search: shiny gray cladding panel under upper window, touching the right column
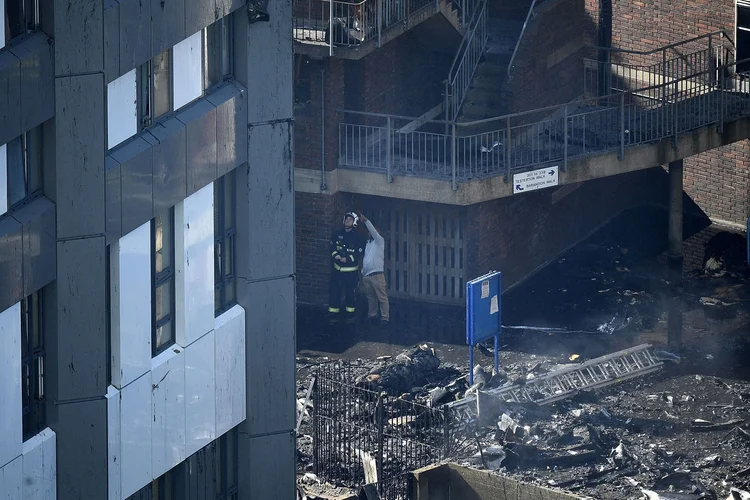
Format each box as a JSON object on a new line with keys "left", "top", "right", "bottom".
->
{"left": 208, "top": 84, "right": 247, "bottom": 177}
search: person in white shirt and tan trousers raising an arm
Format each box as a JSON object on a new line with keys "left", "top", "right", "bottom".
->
{"left": 358, "top": 214, "right": 391, "bottom": 326}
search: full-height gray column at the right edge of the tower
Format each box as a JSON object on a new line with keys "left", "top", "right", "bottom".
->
{"left": 234, "top": 2, "right": 296, "bottom": 500}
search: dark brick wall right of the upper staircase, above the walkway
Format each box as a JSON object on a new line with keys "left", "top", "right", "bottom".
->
{"left": 509, "top": 0, "right": 589, "bottom": 112}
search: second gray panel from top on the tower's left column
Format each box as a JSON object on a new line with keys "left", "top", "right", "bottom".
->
{"left": 55, "top": 73, "right": 106, "bottom": 238}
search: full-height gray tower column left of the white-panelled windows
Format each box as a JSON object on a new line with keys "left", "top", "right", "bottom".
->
{"left": 45, "top": 0, "right": 109, "bottom": 500}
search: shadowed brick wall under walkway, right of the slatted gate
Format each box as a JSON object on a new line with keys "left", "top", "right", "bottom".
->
{"left": 467, "top": 168, "right": 667, "bottom": 287}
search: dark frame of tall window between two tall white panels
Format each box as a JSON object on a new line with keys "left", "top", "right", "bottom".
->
{"left": 151, "top": 207, "right": 176, "bottom": 357}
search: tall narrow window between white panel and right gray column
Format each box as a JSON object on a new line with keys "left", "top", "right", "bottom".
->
{"left": 214, "top": 171, "right": 237, "bottom": 316}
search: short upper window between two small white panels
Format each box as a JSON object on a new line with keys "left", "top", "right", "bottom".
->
{"left": 137, "top": 50, "right": 172, "bottom": 129}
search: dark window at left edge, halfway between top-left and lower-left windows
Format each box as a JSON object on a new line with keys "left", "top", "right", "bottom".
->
{"left": 6, "top": 127, "right": 42, "bottom": 208}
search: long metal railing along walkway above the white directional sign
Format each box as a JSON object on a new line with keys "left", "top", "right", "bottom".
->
{"left": 339, "top": 55, "right": 750, "bottom": 189}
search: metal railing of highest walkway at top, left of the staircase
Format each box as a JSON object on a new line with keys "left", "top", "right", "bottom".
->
{"left": 292, "top": 0, "right": 440, "bottom": 55}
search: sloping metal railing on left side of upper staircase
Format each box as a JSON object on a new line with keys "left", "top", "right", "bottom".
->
{"left": 443, "top": 0, "right": 487, "bottom": 120}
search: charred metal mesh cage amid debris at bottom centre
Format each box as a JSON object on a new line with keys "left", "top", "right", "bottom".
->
{"left": 312, "top": 361, "right": 457, "bottom": 500}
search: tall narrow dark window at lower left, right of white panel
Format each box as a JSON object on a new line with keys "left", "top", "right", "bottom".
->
{"left": 21, "top": 290, "right": 47, "bottom": 441}
